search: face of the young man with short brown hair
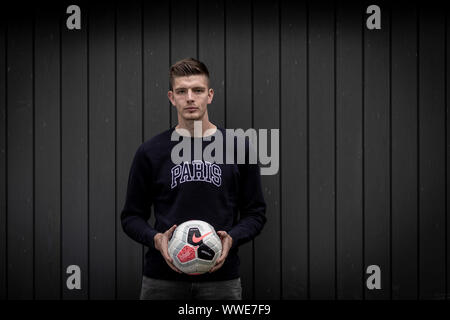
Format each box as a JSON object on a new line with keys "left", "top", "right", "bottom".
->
{"left": 167, "top": 75, "right": 214, "bottom": 120}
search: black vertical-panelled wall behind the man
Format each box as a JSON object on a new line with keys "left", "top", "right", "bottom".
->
{"left": 0, "top": 0, "right": 450, "bottom": 300}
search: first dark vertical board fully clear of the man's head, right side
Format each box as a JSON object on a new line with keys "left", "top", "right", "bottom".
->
{"left": 225, "top": 0, "right": 254, "bottom": 299}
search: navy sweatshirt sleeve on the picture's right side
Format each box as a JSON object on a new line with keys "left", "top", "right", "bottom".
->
{"left": 228, "top": 137, "right": 266, "bottom": 249}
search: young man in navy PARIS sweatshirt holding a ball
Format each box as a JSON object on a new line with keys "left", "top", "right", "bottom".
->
{"left": 121, "top": 58, "right": 266, "bottom": 300}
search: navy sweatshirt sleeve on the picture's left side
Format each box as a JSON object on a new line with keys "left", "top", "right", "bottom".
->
{"left": 121, "top": 145, "right": 157, "bottom": 248}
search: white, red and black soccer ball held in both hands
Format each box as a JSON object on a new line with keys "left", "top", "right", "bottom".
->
{"left": 168, "top": 220, "right": 222, "bottom": 275}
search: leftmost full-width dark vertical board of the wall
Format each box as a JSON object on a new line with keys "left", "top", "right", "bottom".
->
{"left": 6, "top": 10, "right": 34, "bottom": 299}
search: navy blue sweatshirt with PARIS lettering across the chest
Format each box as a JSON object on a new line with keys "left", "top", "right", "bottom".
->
{"left": 121, "top": 127, "right": 266, "bottom": 281}
